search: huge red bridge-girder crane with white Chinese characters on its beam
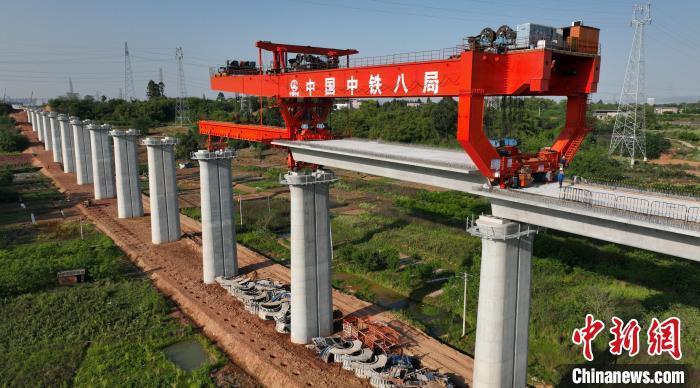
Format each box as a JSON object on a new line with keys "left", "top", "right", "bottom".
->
{"left": 199, "top": 22, "right": 600, "bottom": 186}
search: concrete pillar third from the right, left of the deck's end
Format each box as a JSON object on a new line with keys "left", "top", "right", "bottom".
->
{"left": 192, "top": 150, "right": 238, "bottom": 284}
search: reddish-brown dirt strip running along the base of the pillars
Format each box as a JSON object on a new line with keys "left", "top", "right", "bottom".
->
{"left": 16, "top": 113, "right": 473, "bottom": 387}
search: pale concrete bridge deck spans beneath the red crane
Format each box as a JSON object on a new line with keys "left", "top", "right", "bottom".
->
{"left": 272, "top": 139, "right": 700, "bottom": 261}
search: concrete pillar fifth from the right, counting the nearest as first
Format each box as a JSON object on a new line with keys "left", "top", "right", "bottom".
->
{"left": 109, "top": 129, "right": 143, "bottom": 218}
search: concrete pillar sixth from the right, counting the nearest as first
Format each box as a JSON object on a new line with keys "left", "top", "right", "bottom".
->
{"left": 88, "top": 124, "right": 116, "bottom": 199}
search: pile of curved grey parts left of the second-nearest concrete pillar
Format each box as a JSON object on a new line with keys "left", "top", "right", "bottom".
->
{"left": 215, "top": 276, "right": 291, "bottom": 333}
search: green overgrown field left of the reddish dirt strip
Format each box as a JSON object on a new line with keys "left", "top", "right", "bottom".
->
{"left": 0, "top": 169, "right": 235, "bottom": 387}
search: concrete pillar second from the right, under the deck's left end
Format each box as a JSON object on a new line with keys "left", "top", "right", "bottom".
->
{"left": 283, "top": 170, "right": 335, "bottom": 344}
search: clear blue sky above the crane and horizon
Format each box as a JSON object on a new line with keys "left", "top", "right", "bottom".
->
{"left": 0, "top": 0, "right": 700, "bottom": 101}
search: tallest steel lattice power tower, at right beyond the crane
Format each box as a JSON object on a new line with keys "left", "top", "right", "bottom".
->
{"left": 608, "top": 3, "right": 651, "bottom": 166}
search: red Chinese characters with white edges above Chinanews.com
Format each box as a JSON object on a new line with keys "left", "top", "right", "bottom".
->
{"left": 571, "top": 314, "right": 683, "bottom": 361}
